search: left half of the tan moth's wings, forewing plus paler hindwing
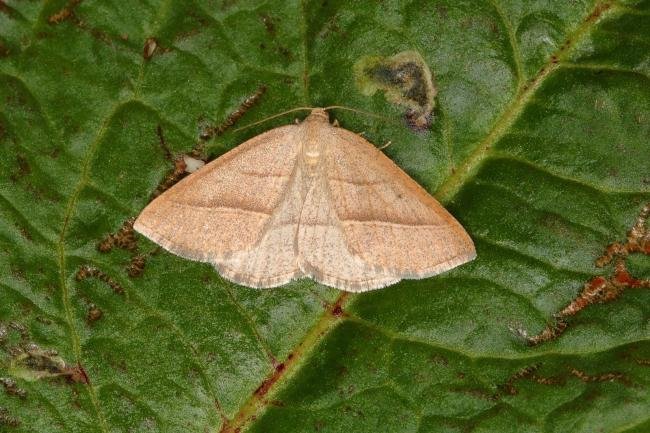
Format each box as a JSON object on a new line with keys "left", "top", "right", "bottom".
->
{"left": 134, "top": 125, "right": 302, "bottom": 287}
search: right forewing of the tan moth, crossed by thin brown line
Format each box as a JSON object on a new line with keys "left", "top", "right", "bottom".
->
{"left": 324, "top": 128, "right": 476, "bottom": 279}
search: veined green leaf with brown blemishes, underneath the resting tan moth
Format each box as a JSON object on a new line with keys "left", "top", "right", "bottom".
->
{"left": 0, "top": 0, "right": 650, "bottom": 433}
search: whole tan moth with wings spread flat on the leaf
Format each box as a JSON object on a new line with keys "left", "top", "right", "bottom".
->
{"left": 133, "top": 108, "right": 476, "bottom": 292}
